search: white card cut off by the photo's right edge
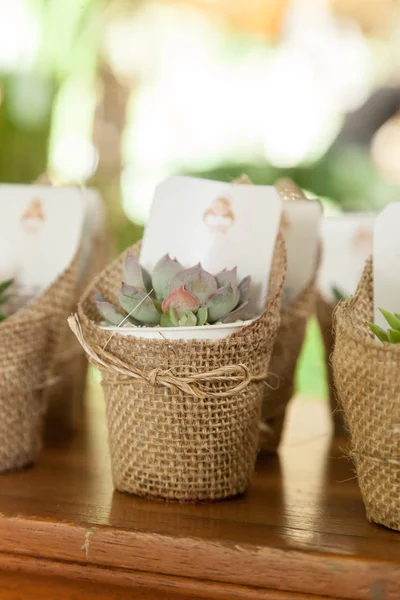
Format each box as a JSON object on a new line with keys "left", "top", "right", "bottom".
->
{"left": 374, "top": 202, "right": 400, "bottom": 329}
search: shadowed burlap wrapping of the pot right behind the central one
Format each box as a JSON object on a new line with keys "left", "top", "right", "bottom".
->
{"left": 260, "top": 279, "right": 316, "bottom": 454}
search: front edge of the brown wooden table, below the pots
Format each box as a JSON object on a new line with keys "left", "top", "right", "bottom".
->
{"left": 0, "top": 516, "right": 400, "bottom": 600}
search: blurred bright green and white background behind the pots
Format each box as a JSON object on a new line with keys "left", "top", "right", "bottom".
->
{"left": 0, "top": 0, "right": 400, "bottom": 397}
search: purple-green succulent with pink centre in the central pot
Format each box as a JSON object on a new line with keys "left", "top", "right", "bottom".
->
{"left": 95, "top": 252, "right": 251, "bottom": 327}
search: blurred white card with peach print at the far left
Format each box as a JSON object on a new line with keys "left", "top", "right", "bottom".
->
{"left": 0, "top": 184, "right": 85, "bottom": 295}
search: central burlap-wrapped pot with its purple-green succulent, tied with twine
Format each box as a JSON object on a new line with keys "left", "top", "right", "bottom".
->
{"left": 69, "top": 239, "right": 285, "bottom": 502}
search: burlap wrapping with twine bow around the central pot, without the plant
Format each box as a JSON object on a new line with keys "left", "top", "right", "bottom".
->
{"left": 70, "top": 239, "right": 286, "bottom": 502}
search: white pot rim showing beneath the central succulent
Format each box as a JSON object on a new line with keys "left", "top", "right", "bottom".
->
{"left": 99, "top": 319, "right": 254, "bottom": 341}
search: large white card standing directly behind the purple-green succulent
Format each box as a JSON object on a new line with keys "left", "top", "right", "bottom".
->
{"left": 140, "top": 176, "right": 282, "bottom": 313}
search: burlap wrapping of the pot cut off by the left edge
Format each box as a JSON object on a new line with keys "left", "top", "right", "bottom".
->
{"left": 0, "top": 260, "right": 76, "bottom": 472}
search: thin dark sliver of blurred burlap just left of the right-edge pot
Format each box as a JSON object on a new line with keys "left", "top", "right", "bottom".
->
{"left": 316, "top": 294, "right": 347, "bottom": 436}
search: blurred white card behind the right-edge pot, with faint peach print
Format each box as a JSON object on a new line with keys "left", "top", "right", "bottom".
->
{"left": 318, "top": 212, "right": 376, "bottom": 303}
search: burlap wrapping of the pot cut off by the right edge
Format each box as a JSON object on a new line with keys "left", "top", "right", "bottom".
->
{"left": 332, "top": 260, "right": 400, "bottom": 530}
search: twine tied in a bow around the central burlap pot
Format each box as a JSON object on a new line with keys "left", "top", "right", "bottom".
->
{"left": 68, "top": 315, "right": 274, "bottom": 399}
